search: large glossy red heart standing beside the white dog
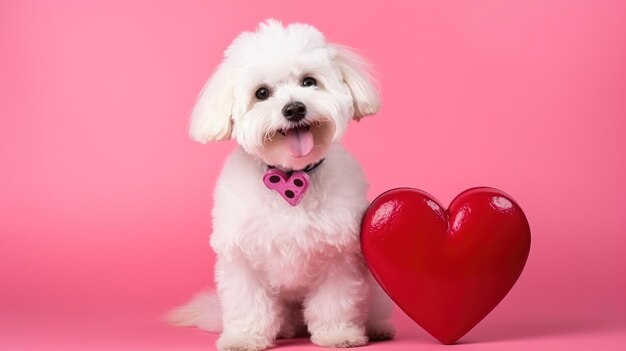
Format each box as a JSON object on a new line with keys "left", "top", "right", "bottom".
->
{"left": 361, "top": 188, "right": 530, "bottom": 344}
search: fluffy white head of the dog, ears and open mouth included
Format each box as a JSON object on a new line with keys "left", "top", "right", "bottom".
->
{"left": 190, "top": 20, "right": 380, "bottom": 169}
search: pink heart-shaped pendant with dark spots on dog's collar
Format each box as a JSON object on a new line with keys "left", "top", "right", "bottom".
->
{"left": 263, "top": 168, "right": 309, "bottom": 206}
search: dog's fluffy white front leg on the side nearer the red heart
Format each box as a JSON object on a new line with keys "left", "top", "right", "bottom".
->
{"left": 304, "top": 253, "right": 369, "bottom": 347}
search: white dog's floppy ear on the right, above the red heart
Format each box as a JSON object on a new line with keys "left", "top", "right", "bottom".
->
{"left": 332, "top": 45, "right": 380, "bottom": 120}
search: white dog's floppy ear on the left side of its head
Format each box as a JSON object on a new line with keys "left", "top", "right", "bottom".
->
{"left": 189, "top": 63, "right": 234, "bottom": 144}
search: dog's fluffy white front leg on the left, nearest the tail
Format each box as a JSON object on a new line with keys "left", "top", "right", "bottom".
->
{"left": 216, "top": 257, "right": 280, "bottom": 351}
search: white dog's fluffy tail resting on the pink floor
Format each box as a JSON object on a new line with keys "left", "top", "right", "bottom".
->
{"left": 165, "top": 291, "right": 222, "bottom": 333}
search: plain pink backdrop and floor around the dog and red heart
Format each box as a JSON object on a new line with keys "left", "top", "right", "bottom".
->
{"left": 0, "top": 0, "right": 626, "bottom": 350}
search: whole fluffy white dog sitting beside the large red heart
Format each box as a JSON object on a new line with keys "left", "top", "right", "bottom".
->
{"left": 170, "top": 20, "right": 394, "bottom": 350}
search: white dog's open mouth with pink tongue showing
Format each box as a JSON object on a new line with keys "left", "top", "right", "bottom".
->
{"left": 266, "top": 120, "right": 329, "bottom": 158}
